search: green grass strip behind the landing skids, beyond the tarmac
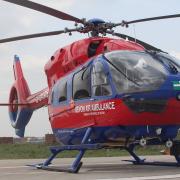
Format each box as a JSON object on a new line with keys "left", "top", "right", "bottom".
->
{"left": 0, "top": 144, "right": 164, "bottom": 159}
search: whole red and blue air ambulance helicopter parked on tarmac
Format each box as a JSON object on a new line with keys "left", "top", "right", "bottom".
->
{"left": 0, "top": 0, "right": 180, "bottom": 173}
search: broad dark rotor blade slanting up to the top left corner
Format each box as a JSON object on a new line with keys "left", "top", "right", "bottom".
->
{"left": 3, "top": 0, "right": 84, "bottom": 24}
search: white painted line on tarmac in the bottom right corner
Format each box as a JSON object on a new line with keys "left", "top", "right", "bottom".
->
{"left": 96, "top": 174, "right": 180, "bottom": 180}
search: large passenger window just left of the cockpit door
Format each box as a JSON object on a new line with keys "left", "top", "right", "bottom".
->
{"left": 73, "top": 67, "right": 91, "bottom": 99}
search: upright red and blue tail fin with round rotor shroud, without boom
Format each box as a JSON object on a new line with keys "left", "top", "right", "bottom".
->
{"left": 9, "top": 55, "right": 33, "bottom": 137}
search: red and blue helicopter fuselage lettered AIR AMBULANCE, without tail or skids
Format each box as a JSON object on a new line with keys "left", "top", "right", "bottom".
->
{"left": 45, "top": 38, "right": 180, "bottom": 144}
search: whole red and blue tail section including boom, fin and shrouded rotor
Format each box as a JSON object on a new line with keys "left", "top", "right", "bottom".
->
{"left": 6, "top": 56, "right": 49, "bottom": 137}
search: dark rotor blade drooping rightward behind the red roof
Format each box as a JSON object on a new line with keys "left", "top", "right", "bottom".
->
{"left": 108, "top": 32, "right": 162, "bottom": 51}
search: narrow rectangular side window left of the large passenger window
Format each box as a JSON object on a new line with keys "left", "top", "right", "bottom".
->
{"left": 58, "top": 81, "right": 67, "bottom": 103}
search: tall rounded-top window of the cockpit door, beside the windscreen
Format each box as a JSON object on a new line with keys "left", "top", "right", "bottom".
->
{"left": 92, "top": 62, "right": 112, "bottom": 96}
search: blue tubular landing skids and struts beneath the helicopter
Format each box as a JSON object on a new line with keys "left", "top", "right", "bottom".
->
{"left": 30, "top": 127, "right": 180, "bottom": 173}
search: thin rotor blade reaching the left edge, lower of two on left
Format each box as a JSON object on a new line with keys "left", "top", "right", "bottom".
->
{"left": 0, "top": 30, "right": 65, "bottom": 43}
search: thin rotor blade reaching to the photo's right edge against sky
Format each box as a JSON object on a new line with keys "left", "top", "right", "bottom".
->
{"left": 118, "top": 14, "right": 180, "bottom": 26}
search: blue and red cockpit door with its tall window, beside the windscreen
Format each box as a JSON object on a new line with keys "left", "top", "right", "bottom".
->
{"left": 91, "top": 60, "right": 115, "bottom": 126}
